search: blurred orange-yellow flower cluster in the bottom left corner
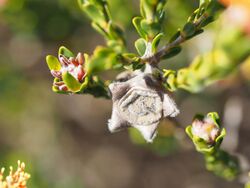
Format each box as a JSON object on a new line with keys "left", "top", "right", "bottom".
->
{"left": 0, "top": 161, "right": 30, "bottom": 188}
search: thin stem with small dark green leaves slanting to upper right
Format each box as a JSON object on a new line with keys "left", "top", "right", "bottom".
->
{"left": 140, "top": 0, "right": 224, "bottom": 64}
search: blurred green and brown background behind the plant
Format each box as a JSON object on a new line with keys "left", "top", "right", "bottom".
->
{"left": 0, "top": 0, "right": 250, "bottom": 188}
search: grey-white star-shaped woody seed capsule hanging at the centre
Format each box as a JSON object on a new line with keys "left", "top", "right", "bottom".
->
{"left": 108, "top": 67, "right": 179, "bottom": 142}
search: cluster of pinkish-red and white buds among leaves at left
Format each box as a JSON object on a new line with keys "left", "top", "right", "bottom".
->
{"left": 51, "top": 53, "right": 86, "bottom": 91}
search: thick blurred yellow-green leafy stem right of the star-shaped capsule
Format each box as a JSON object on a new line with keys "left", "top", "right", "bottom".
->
{"left": 163, "top": 28, "right": 250, "bottom": 92}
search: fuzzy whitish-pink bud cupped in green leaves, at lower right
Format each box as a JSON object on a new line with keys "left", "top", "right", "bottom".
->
{"left": 186, "top": 112, "right": 226, "bottom": 153}
